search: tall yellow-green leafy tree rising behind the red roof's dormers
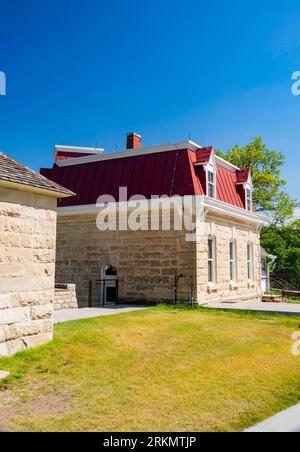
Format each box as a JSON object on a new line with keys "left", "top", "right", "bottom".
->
{"left": 216, "top": 137, "right": 300, "bottom": 226}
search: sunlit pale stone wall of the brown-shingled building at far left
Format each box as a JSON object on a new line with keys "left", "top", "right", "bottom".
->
{"left": 0, "top": 188, "right": 57, "bottom": 356}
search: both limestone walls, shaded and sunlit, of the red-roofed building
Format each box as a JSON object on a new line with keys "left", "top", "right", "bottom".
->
{"left": 56, "top": 209, "right": 261, "bottom": 307}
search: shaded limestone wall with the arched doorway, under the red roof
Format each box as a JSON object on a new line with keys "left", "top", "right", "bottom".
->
{"left": 56, "top": 216, "right": 190, "bottom": 307}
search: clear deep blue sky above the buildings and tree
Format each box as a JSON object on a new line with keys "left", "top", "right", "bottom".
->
{"left": 0, "top": 0, "right": 300, "bottom": 205}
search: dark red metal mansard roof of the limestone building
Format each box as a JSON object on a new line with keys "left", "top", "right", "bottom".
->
{"left": 41, "top": 148, "right": 250, "bottom": 212}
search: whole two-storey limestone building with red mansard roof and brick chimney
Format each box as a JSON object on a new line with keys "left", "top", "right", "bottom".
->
{"left": 42, "top": 134, "right": 266, "bottom": 306}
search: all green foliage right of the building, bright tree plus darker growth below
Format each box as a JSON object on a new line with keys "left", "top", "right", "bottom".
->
{"left": 216, "top": 137, "right": 300, "bottom": 275}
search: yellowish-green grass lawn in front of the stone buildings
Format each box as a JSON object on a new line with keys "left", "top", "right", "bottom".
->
{"left": 0, "top": 307, "right": 300, "bottom": 432}
